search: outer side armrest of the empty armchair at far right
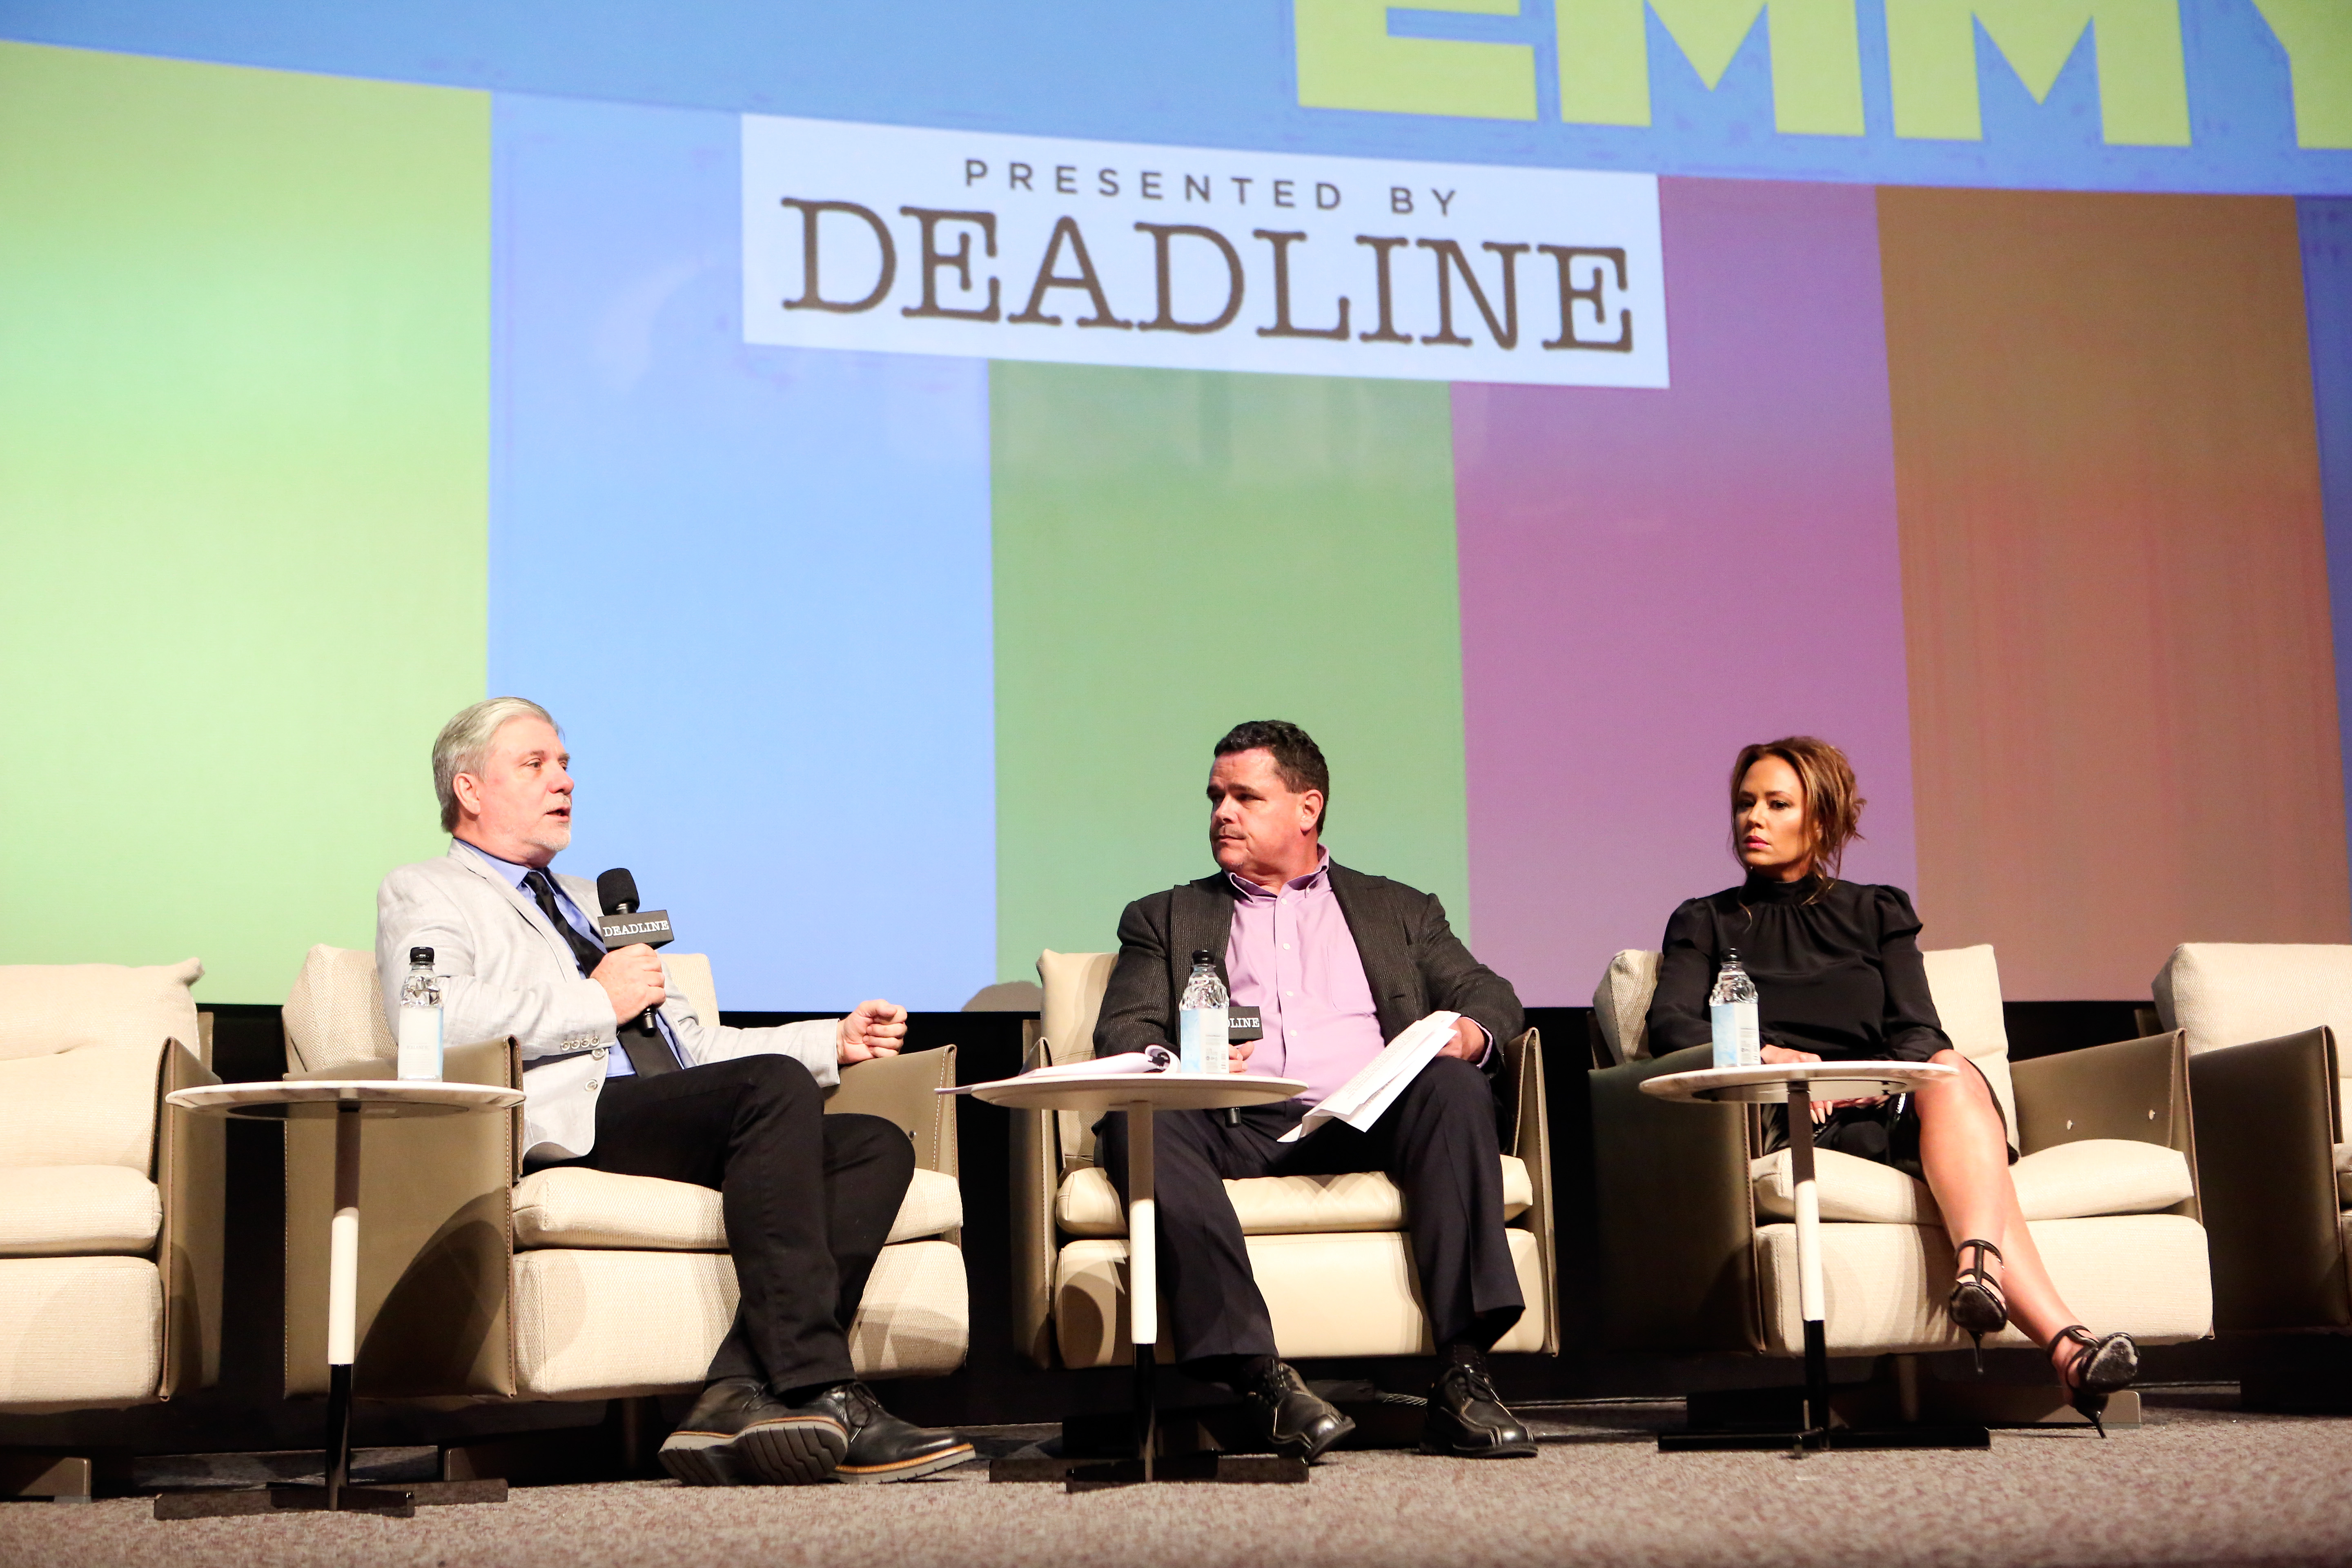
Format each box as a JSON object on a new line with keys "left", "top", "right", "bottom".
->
{"left": 2190, "top": 1027, "right": 2352, "bottom": 1331}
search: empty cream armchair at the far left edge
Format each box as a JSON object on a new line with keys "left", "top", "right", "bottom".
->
{"left": 0, "top": 959, "right": 228, "bottom": 1429}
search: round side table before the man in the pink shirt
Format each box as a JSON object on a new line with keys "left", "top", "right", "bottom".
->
{"left": 971, "top": 1072, "right": 1308, "bottom": 1481}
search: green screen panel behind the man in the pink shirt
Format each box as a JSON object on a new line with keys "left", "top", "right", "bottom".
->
{"left": 990, "top": 362, "right": 1468, "bottom": 980}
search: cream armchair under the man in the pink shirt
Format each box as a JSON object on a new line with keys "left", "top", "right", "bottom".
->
{"left": 1007, "top": 952, "right": 1559, "bottom": 1366}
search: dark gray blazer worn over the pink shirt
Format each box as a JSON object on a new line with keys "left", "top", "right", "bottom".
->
{"left": 1094, "top": 860, "right": 1522, "bottom": 1069}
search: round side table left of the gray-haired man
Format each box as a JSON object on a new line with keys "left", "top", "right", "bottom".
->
{"left": 155, "top": 1079, "right": 522, "bottom": 1519}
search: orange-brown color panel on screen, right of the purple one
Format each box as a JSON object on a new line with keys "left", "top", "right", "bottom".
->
{"left": 1865, "top": 190, "right": 2352, "bottom": 999}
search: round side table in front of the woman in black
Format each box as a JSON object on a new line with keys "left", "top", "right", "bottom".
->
{"left": 1642, "top": 1060, "right": 1992, "bottom": 1450}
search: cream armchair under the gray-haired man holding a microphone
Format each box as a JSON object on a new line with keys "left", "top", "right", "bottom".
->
{"left": 285, "top": 947, "right": 969, "bottom": 1399}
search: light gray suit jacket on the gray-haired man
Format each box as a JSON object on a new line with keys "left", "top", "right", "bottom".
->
{"left": 376, "top": 844, "right": 840, "bottom": 1159}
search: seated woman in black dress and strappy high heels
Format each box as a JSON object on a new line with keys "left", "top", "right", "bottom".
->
{"left": 1649, "top": 736, "right": 2140, "bottom": 1434}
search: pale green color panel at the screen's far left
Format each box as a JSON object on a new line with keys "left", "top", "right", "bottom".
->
{"left": 0, "top": 45, "right": 489, "bottom": 1002}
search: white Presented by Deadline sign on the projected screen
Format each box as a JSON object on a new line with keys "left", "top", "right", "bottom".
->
{"left": 743, "top": 115, "right": 1668, "bottom": 388}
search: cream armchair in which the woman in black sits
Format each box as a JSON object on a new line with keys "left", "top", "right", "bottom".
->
{"left": 1592, "top": 947, "right": 2213, "bottom": 1401}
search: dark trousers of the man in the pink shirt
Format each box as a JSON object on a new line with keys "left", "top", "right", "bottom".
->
{"left": 1096, "top": 1056, "right": 1526, "bottom": 1361}
